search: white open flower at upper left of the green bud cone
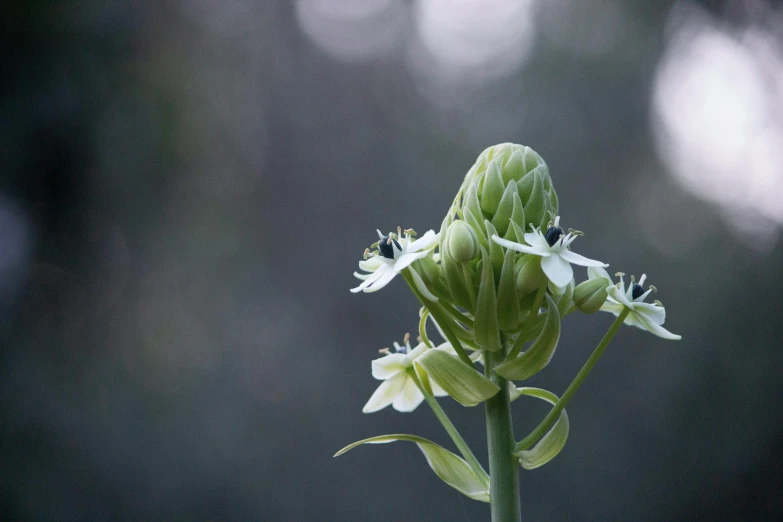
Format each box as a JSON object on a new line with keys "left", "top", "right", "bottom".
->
{"left": 351, "top": 226, "right": 438, "bottom": 301}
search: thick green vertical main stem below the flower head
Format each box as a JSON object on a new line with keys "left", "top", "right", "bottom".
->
{"left": 484, "top": 350, "right": 522, "bottom": 522}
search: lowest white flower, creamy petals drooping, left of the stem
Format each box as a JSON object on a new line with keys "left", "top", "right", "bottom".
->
{"left": 362, "top": 339, "right": 457, "bottom": 413}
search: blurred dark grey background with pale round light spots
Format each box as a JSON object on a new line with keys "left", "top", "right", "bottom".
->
{"left": 0, "top": 0, "right": 783, "bottom": 521}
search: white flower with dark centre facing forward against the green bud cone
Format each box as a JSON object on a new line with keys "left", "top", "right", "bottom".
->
{"left": 492, "top": 216, "right": 609, "bottom": 288}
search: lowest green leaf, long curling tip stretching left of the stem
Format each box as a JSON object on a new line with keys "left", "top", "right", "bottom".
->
{"left": 334, "top": 434, "right": 489, "bottom": 502}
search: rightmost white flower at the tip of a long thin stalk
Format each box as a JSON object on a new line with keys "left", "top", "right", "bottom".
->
{"left": 587, "top": 268, "right": 682, "bottom": 341}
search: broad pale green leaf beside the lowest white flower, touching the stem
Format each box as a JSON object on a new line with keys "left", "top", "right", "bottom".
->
{"left": 413, "top": 350, "right": 500, "bottom": 406}
